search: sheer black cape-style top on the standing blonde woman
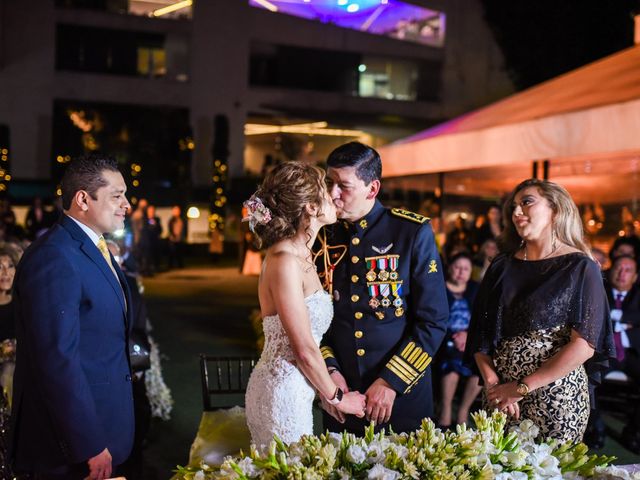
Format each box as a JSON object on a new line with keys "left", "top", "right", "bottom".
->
{"left": 465, "top": 253, "right": 615, "bottom": 381}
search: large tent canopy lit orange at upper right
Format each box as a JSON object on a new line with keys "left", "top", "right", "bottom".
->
{"left": 379, "top": 46, "right": 640, "bottom": 202}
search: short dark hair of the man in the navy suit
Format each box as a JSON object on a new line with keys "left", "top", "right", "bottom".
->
{"left": 62, "top": 155, "right": 119, "bottom": 210}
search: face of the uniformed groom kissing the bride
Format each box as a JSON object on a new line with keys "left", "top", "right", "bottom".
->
{"left": 327, "top": 167, "right": 377, "bottom": 222}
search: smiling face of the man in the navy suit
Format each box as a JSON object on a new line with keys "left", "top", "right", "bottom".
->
{"left": 85, "top": 170, "right": 130, "bottom": 234}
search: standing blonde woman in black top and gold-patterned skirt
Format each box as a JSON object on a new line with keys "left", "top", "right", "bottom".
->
{"left": 466, "top": 180, "right": 615, "bottom": 441}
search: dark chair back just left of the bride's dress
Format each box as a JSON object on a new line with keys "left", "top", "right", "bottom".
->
{"left": 200, "top": 354, "right": 258, "bottom": 412}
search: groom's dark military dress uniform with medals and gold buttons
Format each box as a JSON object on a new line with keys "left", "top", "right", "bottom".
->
{"left": 315, "top": 200, "right": 449, "bottom": 435}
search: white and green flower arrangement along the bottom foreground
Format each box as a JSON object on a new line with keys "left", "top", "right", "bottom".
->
{"left": 176, "top": 411, "right": 640, "bottom": 480}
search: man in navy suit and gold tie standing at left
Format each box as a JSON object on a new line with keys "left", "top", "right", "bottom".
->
{"left": 9, "top": 156, "right": 134, "bottom": 480}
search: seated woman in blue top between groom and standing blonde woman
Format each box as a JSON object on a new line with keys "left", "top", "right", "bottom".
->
{"left": 438, "top": 253, "right": 482, "bottom": 428}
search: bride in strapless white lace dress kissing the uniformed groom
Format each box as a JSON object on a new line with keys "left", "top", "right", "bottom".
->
{"left": 243, "top": 163, "right": 365, "bottom": 447}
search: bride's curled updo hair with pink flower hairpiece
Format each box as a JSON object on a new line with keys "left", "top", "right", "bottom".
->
{"left": 245, "top": 162, "right": 327, "bottom": 248}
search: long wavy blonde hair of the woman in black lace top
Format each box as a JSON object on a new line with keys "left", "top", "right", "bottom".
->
{"left": 498, "top": 178, "right": 593, "bottom": 258}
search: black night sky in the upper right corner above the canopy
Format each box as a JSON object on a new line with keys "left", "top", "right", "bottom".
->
{"left": 482, "top": 0, "right": 640, "bottom": 89}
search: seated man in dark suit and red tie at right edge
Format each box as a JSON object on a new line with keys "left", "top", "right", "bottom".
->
{"left": 585, "top": 255, "right": 640, "bottom": 454}
